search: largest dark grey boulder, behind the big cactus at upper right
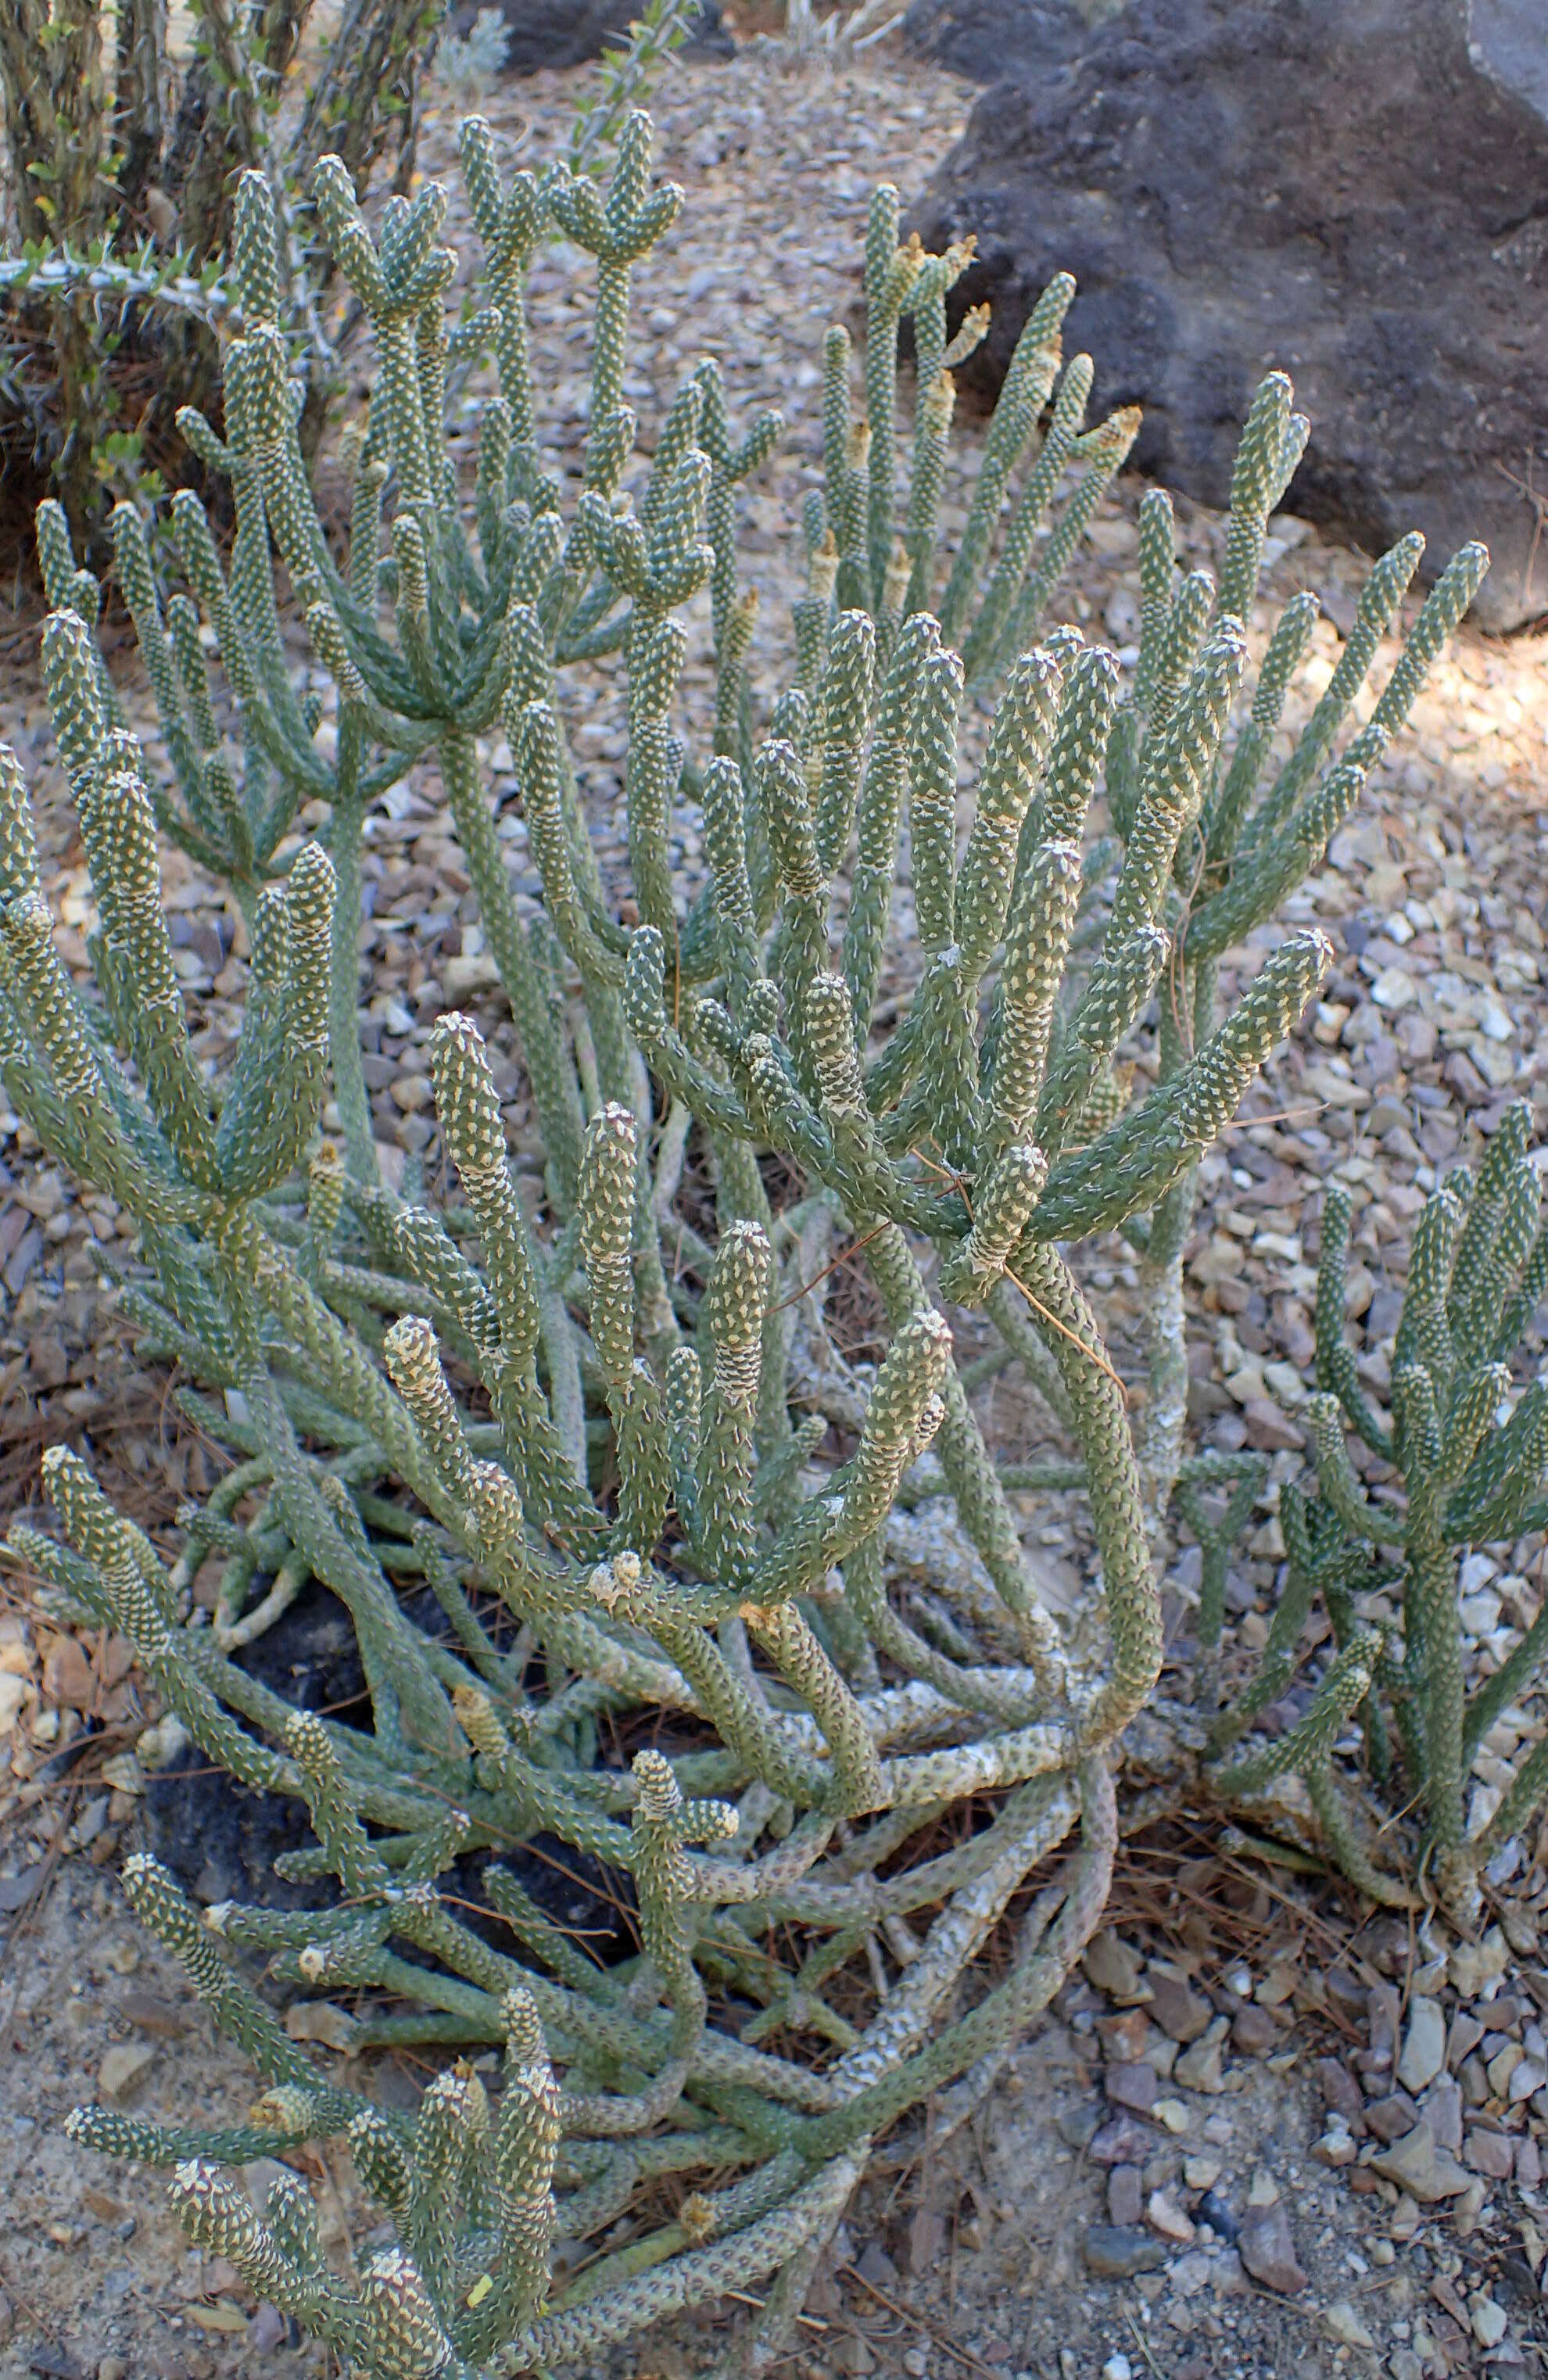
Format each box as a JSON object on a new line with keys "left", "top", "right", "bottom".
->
{"left": 910, "top": 0, "right": 1548, "bottom": 629}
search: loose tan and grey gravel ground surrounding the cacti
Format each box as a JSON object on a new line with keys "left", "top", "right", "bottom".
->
{"left": 0, "top": 23, "right": 1548, "bottom": 2380}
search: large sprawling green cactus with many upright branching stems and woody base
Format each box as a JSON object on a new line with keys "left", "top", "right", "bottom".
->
{"left": 0, "top": 102, "right": 1475, "bottom": 2380}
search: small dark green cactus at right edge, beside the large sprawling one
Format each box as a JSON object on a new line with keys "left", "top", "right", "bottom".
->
{"left": 1215, "top": 1099, "right": 1548, "bottom": 1926}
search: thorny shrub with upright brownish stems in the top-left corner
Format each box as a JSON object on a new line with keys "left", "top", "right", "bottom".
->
{"left": 0, "top": 0, "right": 443, "bottom": 536}
